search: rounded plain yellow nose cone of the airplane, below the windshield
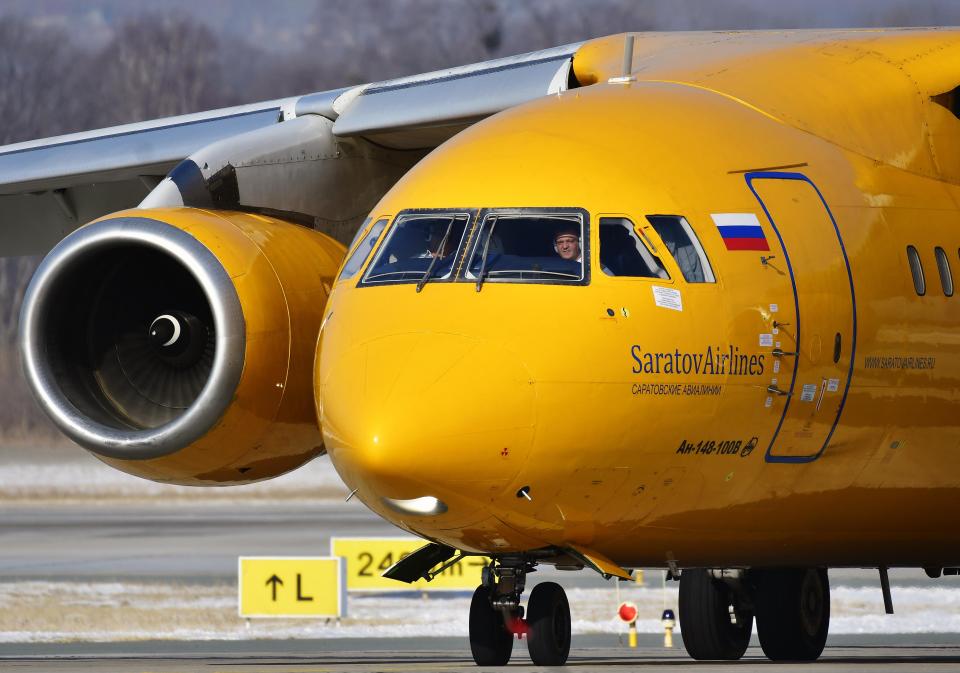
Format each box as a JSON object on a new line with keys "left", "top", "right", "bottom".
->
{"left": 320, "top": 333, "right": 536, "bottom": 517}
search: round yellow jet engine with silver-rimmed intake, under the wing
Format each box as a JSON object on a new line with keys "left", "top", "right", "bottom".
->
{"left": 20, "top": 208, "right": 345, "bottom": 485}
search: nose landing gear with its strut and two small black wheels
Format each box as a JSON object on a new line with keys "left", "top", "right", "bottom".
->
{"left": 470, "top": 559, "right": 570, "bottom": 666}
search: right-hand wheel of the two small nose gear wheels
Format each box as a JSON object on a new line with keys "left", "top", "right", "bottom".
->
{"left": 527, "top": 582, "right": 570, "bottom": 666}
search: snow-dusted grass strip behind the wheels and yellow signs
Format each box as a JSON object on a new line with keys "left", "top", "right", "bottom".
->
{"left": 0, "top": 581, "right": 960, "bottom": 642}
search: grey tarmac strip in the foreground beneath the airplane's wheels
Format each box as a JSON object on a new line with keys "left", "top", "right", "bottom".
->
{"left": 0, "top": 634, "right": 960, "bottom": 673}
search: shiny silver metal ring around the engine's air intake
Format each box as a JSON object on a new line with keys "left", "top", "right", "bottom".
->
{"left": 19, "top": 217, "right": 246, "bottom": 460}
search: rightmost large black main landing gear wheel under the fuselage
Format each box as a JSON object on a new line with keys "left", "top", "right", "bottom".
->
{"left": 755, "top": 568, "right": 830, "bottom": 661}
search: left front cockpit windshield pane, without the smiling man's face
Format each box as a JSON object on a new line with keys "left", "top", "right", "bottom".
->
{"left": 363, "top": 212, "right": 470, "bottom": 285}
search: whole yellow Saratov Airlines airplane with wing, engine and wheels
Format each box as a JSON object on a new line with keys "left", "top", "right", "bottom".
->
{"left": 0, "top": 29, "right": 960, "bottom": 665}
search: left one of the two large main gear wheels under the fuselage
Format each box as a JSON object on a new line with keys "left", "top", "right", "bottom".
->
{"left": 679, "top": 568, "right": 753, "bottom": 660}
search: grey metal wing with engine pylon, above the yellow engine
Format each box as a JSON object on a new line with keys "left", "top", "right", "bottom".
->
{"left": 0, "top": 44, "right": 580, "bottom": 256}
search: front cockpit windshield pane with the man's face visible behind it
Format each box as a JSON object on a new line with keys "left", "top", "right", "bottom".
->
{"left": 465, "top": 211, "right": 589, "bottom": 283}
